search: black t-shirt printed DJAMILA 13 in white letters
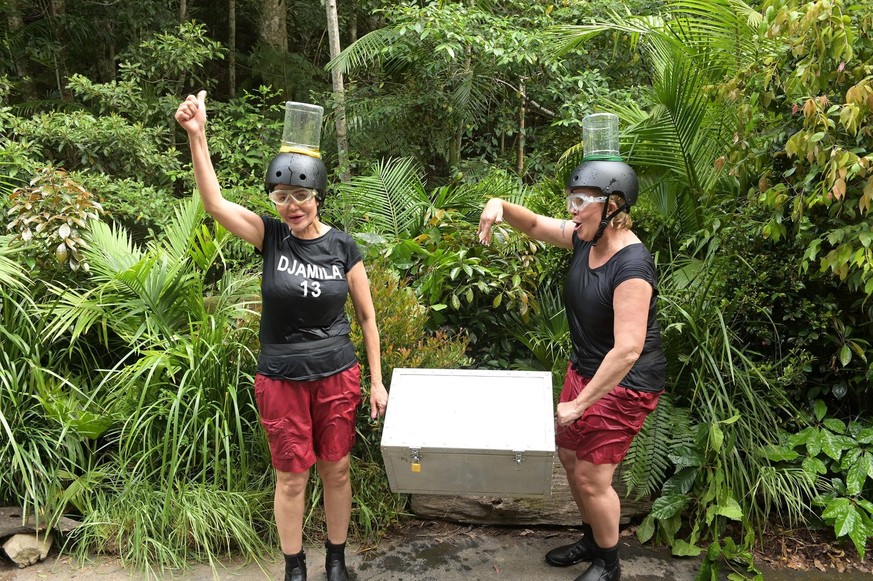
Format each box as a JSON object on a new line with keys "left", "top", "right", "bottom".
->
{"left": 258, "top": 216, "right": 362, "bottom": 380}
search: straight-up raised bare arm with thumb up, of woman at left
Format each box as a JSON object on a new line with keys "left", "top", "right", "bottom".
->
{"left": 175, "top": 91, "right": 264, "bottom": 250}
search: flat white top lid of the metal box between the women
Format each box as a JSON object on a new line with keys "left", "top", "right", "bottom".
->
{"left": 382, "top": 368, "right": 555, "bottom": 456}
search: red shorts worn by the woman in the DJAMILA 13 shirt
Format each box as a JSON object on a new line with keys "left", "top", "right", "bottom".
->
{"left": 255, "top": 363, "right": 361, "bottom": 473}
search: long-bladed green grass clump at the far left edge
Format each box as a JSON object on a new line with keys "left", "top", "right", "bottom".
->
{"left": 0, "top": 237, "right": 105, "bottom": 526}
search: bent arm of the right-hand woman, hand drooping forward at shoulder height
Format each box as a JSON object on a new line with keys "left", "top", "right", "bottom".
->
{"left": 478, "top": 198, "right": 575, "bottom": 248}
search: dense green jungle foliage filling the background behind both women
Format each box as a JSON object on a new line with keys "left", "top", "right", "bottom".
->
{"left": 0, "top": 0, "right": 873, "bottom": 579}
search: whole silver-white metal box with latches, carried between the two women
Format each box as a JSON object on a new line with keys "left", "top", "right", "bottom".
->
{"left": 382, "top": 368, "right": 555, "bottom": 496}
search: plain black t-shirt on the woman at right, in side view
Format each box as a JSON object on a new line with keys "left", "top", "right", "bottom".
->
{"left": 564, "top": 236, "right": 667, "bottom": 392}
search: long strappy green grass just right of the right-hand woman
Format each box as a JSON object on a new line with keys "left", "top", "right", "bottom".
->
{"left": 660, "top": 253, "right": 810, "bottom": 524}
